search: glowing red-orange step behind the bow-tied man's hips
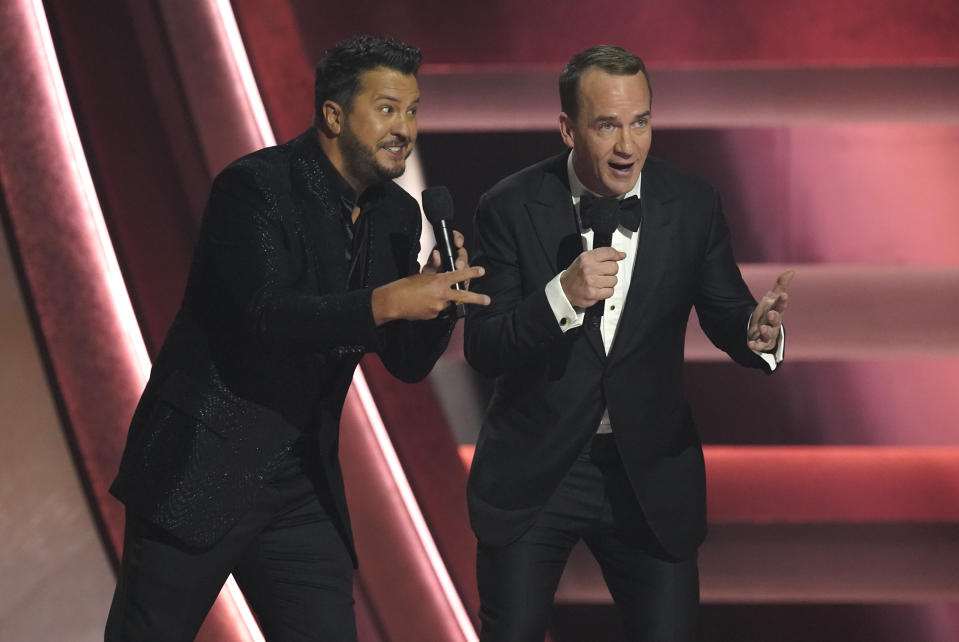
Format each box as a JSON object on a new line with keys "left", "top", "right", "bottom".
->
{"left": 460, "top": 445, "right": 959, "bottom": 524}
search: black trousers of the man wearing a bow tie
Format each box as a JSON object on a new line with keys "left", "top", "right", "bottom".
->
{"left": 477, "top": 435, "right": 699, "bottom": 642}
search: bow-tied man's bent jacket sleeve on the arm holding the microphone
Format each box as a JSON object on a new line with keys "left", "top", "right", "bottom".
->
{"left": 464, "top": 194, "right": 563, "bottom": 377}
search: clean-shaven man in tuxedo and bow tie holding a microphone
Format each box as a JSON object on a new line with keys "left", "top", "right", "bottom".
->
{"left": 465, "top": 46, "right": 791, "bottom": 642}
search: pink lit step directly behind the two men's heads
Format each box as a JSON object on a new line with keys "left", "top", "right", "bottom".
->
{"left": 419, "top": 64, "right": 959, "bottom": 132}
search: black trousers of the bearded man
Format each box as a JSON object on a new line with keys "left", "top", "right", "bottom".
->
{"left": 105, "top": 454, "right": 356, "bottom": 642}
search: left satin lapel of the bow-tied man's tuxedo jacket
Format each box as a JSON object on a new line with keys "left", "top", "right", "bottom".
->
{"left": 526, "top": 154, "right": 606, "bottom": 360}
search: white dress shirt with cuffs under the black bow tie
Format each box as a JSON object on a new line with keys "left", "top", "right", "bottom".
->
{"left": 546, "top": 154, "right": 785, "bottom": 433}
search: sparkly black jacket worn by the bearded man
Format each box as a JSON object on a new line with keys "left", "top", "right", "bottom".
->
{"left": 111, "top": 130, "right": 452, "bottom": 551}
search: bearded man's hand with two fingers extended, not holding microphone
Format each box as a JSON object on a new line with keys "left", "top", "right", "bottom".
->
{"left": 373, "top": 267, "right": 490, "bottom": 326}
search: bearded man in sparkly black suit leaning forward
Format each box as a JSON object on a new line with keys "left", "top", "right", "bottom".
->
{"left": 106, "top": 36, "right": 488, "bottom": 642}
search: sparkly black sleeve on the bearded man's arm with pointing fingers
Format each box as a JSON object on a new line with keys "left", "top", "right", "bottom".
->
{"left": 194, "top": 167, "right": 379, "bottom": 352}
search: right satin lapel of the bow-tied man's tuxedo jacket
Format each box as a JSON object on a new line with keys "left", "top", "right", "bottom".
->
{"left": 610, "top": 175, "right": 677, "bottom": 359}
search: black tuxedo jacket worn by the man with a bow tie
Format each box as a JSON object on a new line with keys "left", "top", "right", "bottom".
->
{"left": 465, "top": 154, "right": 768, "bottom": 557}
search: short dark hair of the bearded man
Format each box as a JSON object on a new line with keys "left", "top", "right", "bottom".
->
{"left": 313, "top": 36, "right": 423, "bottom": 114}
